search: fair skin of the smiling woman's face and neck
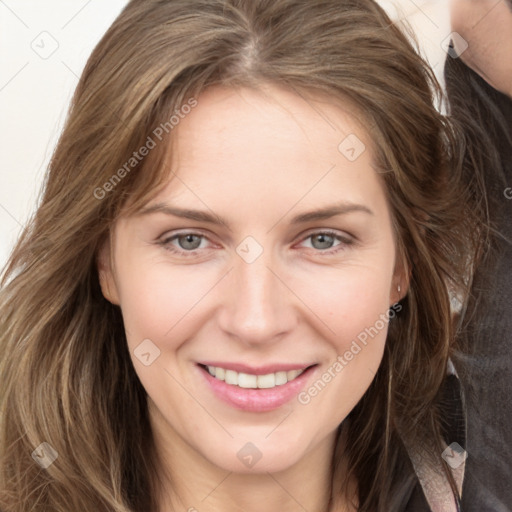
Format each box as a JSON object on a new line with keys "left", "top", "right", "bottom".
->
{"left": 99, "top": 85, "right": 406, "bottom": 512}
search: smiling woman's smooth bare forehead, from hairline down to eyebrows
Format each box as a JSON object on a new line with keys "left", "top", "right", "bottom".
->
{"left": 130, "top": 86, "right": 387, "bottom": 228}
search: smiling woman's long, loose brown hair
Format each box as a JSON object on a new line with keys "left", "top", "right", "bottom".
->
{"left": 0, "top": 0, "right": 476, "bottom": 512}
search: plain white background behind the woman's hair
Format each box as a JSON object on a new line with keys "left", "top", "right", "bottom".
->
{"left": 0, "top": 0, "right": 450, "bottom": 269}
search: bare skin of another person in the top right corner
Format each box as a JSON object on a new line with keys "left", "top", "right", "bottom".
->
{"left": 451, "top": 0, "right": 512, "bottom": 98}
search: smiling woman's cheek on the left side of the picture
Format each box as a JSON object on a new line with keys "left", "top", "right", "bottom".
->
{"left": 118, "top": 258, "right": 213, "bottom": 422}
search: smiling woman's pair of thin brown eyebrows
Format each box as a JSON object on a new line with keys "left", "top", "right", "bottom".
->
{"left": 138, "top": 202, "right": 374, "bottom": 227}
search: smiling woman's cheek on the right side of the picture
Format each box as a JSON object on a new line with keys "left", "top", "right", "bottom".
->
{"left": 294, "top": 258, "right": 393, "bottom": 390}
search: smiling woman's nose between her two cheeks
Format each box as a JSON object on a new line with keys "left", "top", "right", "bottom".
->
{"left": 219, "top": 247, "right": 297, "bottom": 346}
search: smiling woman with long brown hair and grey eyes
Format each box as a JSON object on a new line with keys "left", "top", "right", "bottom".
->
{"left": 0, "top": 0, "right": 478, "bottom": 512}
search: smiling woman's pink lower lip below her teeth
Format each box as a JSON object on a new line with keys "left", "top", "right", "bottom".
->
{"left": 199, "top": 366, "right": 314, "bottom": 412}
